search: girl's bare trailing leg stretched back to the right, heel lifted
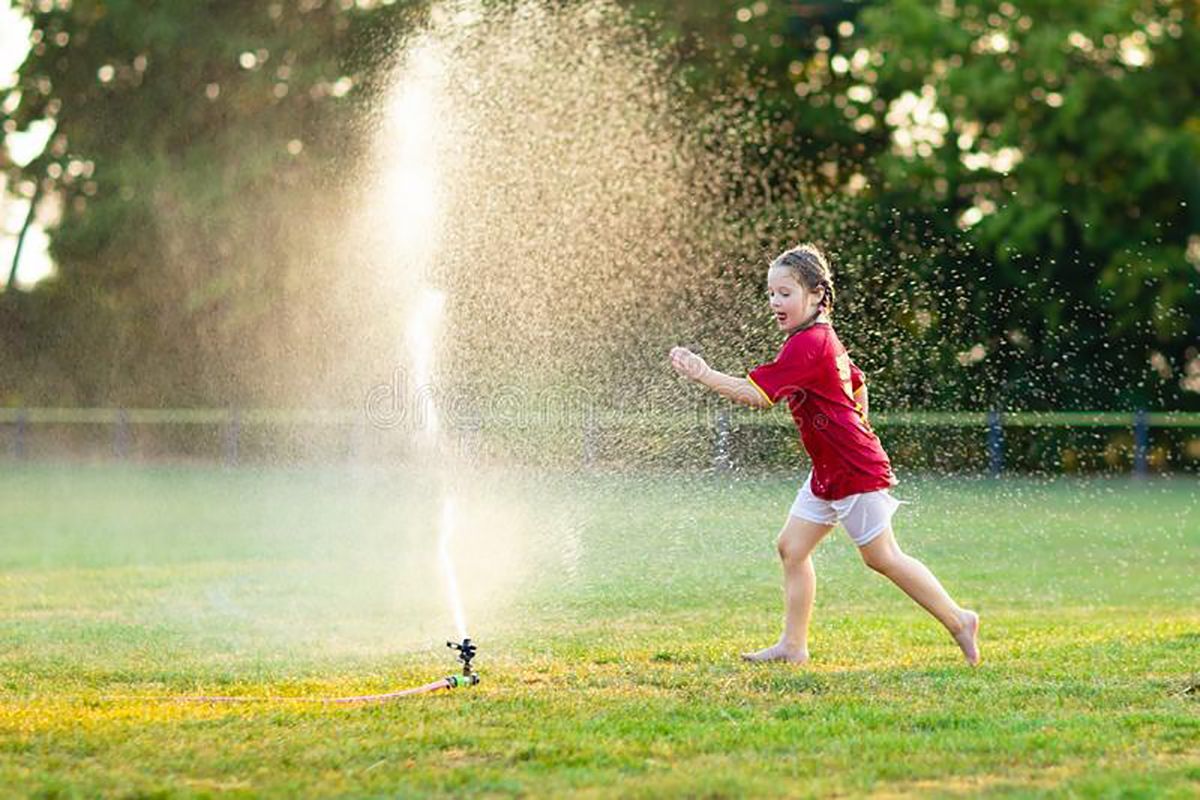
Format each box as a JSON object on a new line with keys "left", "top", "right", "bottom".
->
{"left": 858, "top": 528, "right": 979, "bottom": 666}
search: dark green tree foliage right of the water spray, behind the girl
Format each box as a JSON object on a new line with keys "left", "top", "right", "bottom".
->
{"left": 640, "top": 0, "right": 1200, "bottom": 408}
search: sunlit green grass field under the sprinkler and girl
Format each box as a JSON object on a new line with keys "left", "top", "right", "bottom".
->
{"left": 0, "top": 465, "right": 1200, "bottom": 798}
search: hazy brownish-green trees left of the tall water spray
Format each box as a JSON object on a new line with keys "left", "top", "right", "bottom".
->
{"left": 0, "top": 0, "right": 424, "bottom": 403}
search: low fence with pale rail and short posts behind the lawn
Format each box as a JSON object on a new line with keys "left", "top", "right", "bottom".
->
{"left": 0, "top": 407, "right": 1200, "bottom": 475}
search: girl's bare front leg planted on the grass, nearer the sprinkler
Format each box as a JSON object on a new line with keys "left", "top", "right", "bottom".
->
{"left": 742, "top": 517, "right": 833, "bottom": 663}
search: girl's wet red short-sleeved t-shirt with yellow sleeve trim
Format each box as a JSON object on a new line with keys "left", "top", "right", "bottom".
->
{"left": 749, "top": 321, "right": 896, "bottom": 500}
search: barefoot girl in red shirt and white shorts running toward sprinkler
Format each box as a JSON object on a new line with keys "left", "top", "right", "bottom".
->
{"left": 671, "top": 245, "right": 979, "bottom": 666}
